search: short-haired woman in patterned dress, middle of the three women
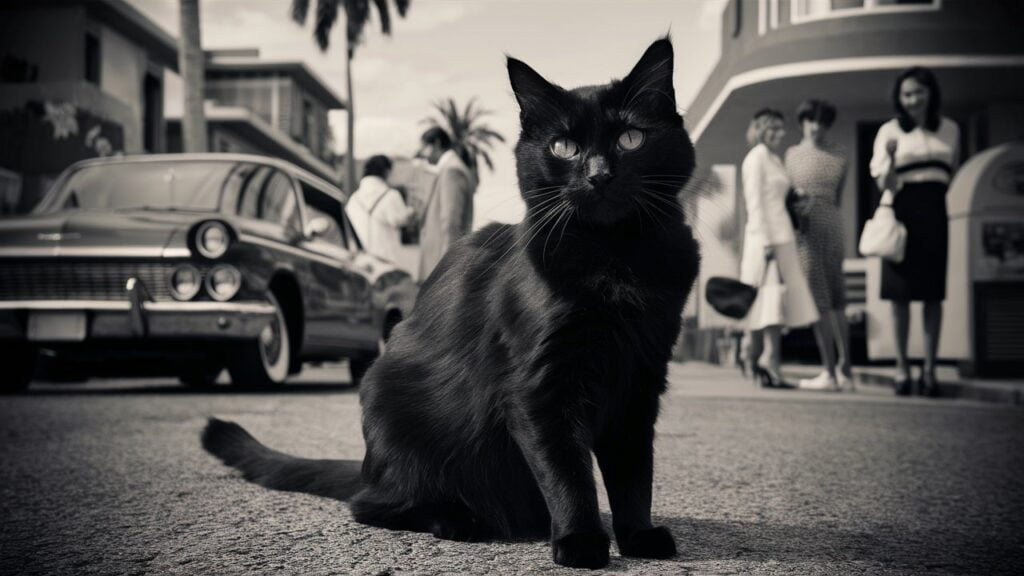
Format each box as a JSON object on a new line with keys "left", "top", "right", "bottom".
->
{"left": 785, "top": 99, "right": 853, "bottom": 390}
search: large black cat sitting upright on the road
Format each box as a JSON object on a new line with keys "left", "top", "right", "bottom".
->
{"left": 203, "top": 38, "right": 698, "bottom": 568}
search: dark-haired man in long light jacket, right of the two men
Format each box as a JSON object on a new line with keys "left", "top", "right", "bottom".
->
{"left": 418, "top": 127, "right": 476, "bottom": 282}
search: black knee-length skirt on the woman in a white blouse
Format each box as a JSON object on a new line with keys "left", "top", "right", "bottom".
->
{"left": 882, "top": 182, "right": 949, "bottom": 301}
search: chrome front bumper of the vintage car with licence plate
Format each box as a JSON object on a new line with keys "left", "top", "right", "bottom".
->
{"left": 0, "top": 294, "right": 274, "bottom": 342}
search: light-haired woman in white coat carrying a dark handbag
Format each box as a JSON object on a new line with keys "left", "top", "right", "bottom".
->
{"left": 740, "top": 109, "right": 818, "bottom": 387}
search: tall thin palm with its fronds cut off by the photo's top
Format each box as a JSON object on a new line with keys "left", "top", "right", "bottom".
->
{"left": 292, "top": 0, "right": 412, "bottom": 194}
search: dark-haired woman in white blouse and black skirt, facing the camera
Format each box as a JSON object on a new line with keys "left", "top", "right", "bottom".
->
{"left": 870, "top": 67, "right": 959, "bottom": 396}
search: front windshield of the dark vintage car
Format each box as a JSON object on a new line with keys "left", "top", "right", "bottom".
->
{"left": 38, "top": 161, "right": 257, "bottom": 212}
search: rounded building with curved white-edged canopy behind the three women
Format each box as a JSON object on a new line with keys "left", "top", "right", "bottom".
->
{"left": 686, "top": 0, "right": 1024, "bottom": 358}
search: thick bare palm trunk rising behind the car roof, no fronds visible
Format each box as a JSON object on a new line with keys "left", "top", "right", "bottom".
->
{"left": 178, "top": 0, "right": 207, "bottom": 152}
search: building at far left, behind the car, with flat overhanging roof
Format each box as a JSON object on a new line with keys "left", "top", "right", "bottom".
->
{"left": 0, "top": 0, "right": 177, "bottom": 213}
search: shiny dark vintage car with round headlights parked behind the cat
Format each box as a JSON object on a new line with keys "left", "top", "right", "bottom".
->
{"left": 0, "top": 154, "right": 416, "bottom": 392}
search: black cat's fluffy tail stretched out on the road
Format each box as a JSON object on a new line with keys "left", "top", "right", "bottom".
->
{"left": 202, "top": 418, "right": 362, "bottom": 500}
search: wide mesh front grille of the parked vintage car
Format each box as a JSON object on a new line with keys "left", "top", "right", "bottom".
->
{"left": 0, "top": 259, "right": 206, "bottom": 301}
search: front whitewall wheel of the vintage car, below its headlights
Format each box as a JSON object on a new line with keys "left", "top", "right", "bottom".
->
{"left": 227, "top": 292, "right": 292, "bottom": 388}
